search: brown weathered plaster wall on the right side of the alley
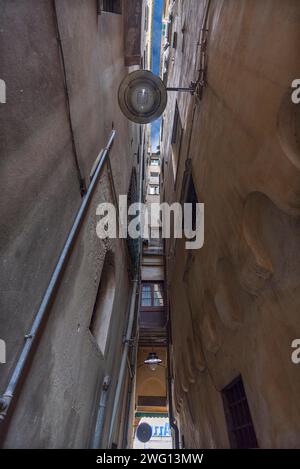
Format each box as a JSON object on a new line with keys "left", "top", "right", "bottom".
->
{"left": 162, "top": 0, "right": 300, "bottom": 447}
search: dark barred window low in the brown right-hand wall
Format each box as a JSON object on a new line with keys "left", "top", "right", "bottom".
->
{"left": 222, "top": 376, "right": 258, "bottom": 449}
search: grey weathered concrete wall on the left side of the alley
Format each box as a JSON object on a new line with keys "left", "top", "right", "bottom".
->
{"left": 0, "top": 0, "right": 138, "bottom": 448}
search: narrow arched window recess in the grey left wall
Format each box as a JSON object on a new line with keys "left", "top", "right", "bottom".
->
{"left": 90, "top": 252, "right": 116, "bottom": 355}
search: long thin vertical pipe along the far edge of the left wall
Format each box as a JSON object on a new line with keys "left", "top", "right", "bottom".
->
{"left": 107, "top": 128, "right": 144, "bottom": 448}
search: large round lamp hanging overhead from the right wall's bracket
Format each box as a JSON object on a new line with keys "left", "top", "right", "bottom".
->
{"left": 118, "top": 70, "right": 168, "bottom": 124}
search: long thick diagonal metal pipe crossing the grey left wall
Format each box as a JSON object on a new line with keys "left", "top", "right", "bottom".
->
{"left": 0, "top": 130, "right": 116, "bottom": 420}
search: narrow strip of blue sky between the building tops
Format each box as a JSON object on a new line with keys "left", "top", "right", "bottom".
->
{"left": 151, "top": 0, "right": 163, "bottom": 151}
